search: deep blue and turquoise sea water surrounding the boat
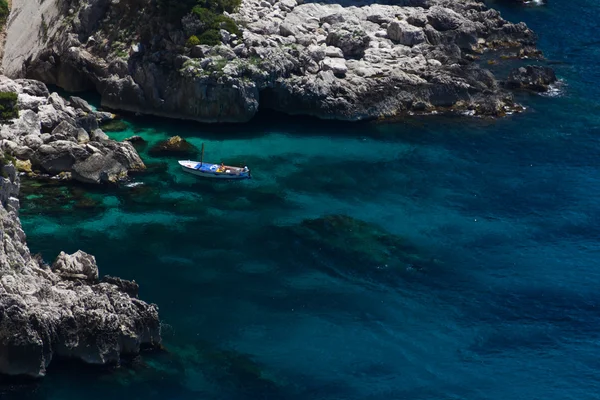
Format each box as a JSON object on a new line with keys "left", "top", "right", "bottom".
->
{"left": 0, "top": 0, "right": 600, "bottom": 400}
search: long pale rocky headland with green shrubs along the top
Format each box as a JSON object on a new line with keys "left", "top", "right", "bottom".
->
{"left": 3, "top": 0, "right": 552, "bottom": 122}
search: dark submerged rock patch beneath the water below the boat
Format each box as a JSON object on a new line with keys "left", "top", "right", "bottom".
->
{"left": 245, "top": 215, "right": 446, "bottom": 287}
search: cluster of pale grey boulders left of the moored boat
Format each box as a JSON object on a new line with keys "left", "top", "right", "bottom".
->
{"left": 0, "top": 76, "right": 145, "bottom": 183}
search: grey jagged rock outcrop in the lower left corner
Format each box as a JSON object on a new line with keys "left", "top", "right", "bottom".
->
{"left": 0, "top": 165, "right": 161, "bottom": 377}
